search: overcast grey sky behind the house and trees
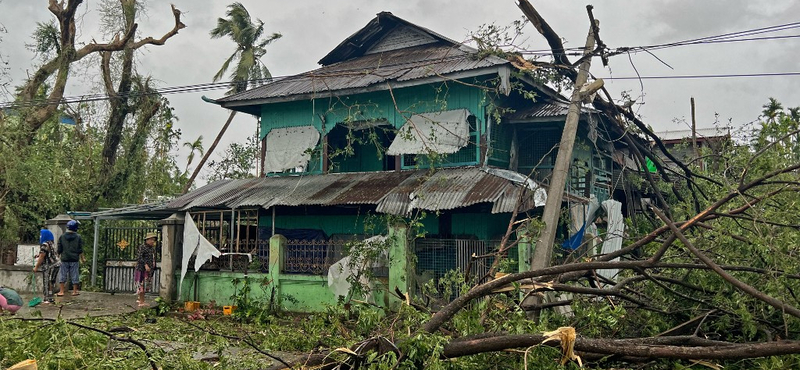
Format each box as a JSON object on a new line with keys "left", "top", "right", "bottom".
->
{"left": 0, "top": 0, "right": 800, "bottom": 184}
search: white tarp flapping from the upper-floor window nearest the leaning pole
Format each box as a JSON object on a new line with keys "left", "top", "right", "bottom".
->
{"left": 386, "top": 109, "right": 470, "bottom": 155}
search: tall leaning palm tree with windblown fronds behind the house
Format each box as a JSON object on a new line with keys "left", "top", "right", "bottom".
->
{"left": 183, "top": 2, "right": 281, "bottom": 193}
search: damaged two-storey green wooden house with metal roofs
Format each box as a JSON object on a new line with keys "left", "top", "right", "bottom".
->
{"left": 148, "top": 12, "right": 636, "bottom": 311}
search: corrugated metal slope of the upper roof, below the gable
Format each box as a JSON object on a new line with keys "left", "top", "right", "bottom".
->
{"left": 217, "top": 42, "right": 509, "bottom": 106}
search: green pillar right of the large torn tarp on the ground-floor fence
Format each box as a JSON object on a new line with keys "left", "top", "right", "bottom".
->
{"left": 388, "top": 223, "right": 414, "bottom": 301}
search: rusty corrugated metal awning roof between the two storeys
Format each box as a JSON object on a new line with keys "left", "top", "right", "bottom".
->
{"left": 165, "top": 167, "right": 548, "bottom": 215}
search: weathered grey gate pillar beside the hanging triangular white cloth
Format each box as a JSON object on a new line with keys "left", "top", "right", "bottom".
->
{"left": 158, "top": 213, "right": 184, "bottom": 302}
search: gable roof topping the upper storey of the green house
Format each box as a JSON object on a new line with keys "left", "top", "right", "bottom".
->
{"left": 215, "top": 12, "right": 511, "bottom": 114}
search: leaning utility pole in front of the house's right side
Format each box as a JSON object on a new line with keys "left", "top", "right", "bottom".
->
{"left": 530, "top": 18, "right": 603, "bottom": 271}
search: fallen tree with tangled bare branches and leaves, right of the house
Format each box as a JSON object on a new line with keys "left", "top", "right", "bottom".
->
{"left": 262, "top": 0, "right": 800, "bottom": 368}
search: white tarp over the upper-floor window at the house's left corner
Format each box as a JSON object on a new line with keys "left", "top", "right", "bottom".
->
{"left": 264, "top": 126, "right": 319, "bottom": 172}
